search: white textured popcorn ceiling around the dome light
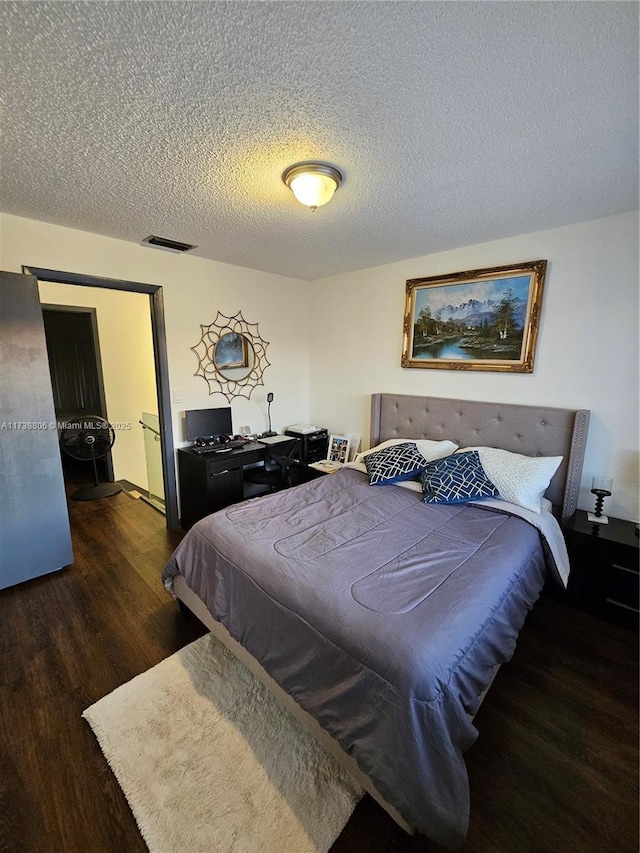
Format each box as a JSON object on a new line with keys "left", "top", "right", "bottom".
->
{"left": 0, "top": 0, "right": 639, "bottom": 279}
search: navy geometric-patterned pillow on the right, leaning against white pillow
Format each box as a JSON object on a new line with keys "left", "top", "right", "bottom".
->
{"left": 421, "top": 450, "right": 498, "bottom": 504}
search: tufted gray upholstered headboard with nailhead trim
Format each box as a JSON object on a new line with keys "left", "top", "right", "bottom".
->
{"left": 369, "top": 394, "right": 589, "bottom": 520}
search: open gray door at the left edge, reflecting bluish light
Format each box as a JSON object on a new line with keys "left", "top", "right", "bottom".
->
{"left": 0, "top": 272, "right": 73, "bottom": 589}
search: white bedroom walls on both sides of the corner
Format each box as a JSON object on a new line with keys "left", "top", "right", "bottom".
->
{"left": 0, "top": 213, "right": 639, "bottom": 520}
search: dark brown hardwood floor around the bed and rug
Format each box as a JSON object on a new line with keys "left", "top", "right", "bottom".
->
{"left": 0, "top": 486, "right": 638, "bottom": 853}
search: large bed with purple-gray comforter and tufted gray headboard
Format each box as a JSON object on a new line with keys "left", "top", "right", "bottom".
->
{"left": 163, "top": 394, "right": 589, "bottom": 849}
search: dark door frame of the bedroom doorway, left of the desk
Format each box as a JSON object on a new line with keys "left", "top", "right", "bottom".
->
{"left": 23, "top": 266, "right": 179, "bottom": 529}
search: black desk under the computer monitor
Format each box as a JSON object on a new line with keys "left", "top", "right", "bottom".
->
{"left": 178, "top": 436, "right": 298, "bottom": 530}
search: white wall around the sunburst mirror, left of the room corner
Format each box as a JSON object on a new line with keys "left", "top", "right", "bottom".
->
{"left": 0, "top": 214, "right": 309, "bottom": 490}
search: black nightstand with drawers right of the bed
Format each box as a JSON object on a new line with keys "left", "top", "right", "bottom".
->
{"left": 563, "top": 509, "right": 640, "bottom": 631}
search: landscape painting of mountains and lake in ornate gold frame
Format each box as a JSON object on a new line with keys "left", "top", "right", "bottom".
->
{"left": 402, "top": 261, "right": 547, "bottom": 373}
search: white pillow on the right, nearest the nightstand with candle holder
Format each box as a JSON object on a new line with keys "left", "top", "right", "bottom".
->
{"left": 460, "top": 447, "right": 562, "bottom": 514}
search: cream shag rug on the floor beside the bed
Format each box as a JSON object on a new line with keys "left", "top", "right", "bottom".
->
{"left": 82, "top": 634, "right": 362, "bottom": 853}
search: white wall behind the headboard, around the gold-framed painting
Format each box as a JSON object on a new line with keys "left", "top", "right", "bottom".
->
{"left": 310, "top": 213, "right": 639, "bottom": 520}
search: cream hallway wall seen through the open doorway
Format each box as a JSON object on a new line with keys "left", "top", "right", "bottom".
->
{"left": 38, "top": 281, "right": 158, "bottom": 489}
